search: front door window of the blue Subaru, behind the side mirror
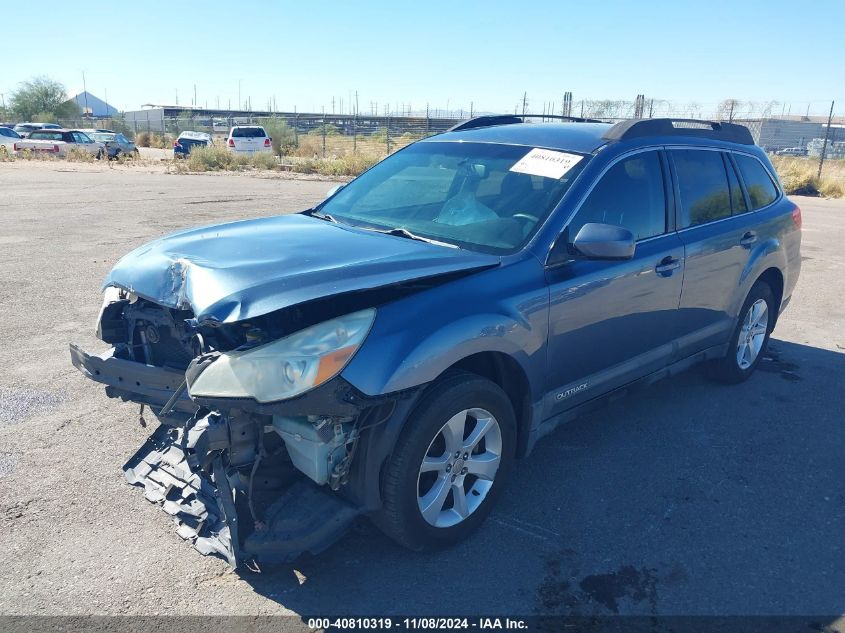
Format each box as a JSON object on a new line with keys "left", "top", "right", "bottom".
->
{"left": 569, "top": 151, "right": 666, "bottom": 241}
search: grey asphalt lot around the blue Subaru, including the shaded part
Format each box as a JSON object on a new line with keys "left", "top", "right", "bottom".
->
{"left": 0, "top": 163, "right": 845, "bottom": 615}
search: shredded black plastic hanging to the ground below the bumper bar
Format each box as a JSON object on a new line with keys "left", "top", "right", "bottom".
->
{"left": 123, "top": 414, "right": 360, "bottom": 568}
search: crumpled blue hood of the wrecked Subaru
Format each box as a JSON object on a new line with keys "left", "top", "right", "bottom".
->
{"left": 103, "top": 214, "right": 500, "bottom": 323}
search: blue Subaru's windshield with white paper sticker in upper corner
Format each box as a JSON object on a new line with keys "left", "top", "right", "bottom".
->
{"left": 319, "top": 141, "right": 587, "bottom": 253}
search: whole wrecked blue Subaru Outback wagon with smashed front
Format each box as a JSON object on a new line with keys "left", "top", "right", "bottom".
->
{"left": 71, "top": 117, "right": 801, "bottom": 566}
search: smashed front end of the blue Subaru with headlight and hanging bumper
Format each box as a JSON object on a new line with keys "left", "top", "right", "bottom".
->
{"left": 70, "top": 288, "right": 409, "bottom": 567}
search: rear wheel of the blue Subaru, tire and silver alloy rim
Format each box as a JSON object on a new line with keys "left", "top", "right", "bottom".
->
{"left": 707, "top": 281, "right": 777, "bottom": 384}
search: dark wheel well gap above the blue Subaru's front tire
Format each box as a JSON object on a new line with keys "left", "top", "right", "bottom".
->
{"left": 447, "top": 352, "right": 531, "bottom": 457}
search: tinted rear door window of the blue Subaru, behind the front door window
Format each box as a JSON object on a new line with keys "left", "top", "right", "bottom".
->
{"left": 672, "top": 149, "right": 731, "bottom": 229}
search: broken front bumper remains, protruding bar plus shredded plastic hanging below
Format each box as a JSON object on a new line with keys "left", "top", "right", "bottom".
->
{"left": 70, "top": 345, "right": 362, "bottom": 567}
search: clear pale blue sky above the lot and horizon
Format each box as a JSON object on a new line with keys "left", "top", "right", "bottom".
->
{"left": 0, "top": 0, "right": 845, "bottom": 114}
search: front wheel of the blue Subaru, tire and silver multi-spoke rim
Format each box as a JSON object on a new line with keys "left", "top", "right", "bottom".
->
{"left": 374, "top": 372, "right": 516, "bottom": 551}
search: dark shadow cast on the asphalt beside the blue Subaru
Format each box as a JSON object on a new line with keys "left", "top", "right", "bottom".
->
{"left": 231, "top": 340, "right": 845, "bottom": 617}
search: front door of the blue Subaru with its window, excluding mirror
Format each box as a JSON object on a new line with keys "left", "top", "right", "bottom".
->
{"left": 546, "top": 149, "right": 684, "bottom": 415}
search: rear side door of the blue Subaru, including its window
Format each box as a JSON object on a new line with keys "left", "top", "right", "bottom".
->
{"left": 669, "top": 148, "right": 758, "bottom": 359}
